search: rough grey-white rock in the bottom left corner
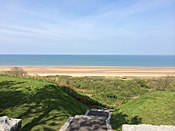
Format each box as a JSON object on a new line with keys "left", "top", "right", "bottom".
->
{"left": 0, "top": 116, "right": 22, "bottom": 131}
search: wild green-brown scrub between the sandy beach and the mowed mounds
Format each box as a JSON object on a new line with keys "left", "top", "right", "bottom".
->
{"left": 42, "top": 76, "right": 175, "bottom": 108}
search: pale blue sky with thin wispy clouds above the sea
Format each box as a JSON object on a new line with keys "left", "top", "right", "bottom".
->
{"left": 0, "top": 0, "right": 175, "bottom": 55}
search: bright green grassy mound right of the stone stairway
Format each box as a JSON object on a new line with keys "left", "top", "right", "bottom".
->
{"left": 111, "top": 91, "right": 175, "bottom": 129}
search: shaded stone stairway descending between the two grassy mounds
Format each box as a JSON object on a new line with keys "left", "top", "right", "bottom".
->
{"left": 60, "top": 109, "right": 112, "bottom": 131}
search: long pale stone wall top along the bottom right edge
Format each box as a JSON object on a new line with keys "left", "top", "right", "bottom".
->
{"left": 122, "top": 124, "right": 175, "bottom": 131}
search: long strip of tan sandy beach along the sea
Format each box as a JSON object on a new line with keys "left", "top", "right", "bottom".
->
{"left": 0, "top": 66, "right": 175, "bottom": 77}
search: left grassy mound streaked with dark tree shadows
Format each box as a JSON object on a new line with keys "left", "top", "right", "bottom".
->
{"left": 0, "top": 75, "right": 87, "bottom": 131}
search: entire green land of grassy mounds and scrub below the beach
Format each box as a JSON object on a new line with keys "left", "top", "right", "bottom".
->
{"left": 0, "top": 75, "right": 175, "bottom": 131}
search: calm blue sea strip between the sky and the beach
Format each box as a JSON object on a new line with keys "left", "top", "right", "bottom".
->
{"left": 0, "top": 55, "right": 175, "bottom": 67}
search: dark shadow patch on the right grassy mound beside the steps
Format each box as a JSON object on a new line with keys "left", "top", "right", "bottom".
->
{"left": 111, "top": 112, "right": 142, "bottom": 131}
